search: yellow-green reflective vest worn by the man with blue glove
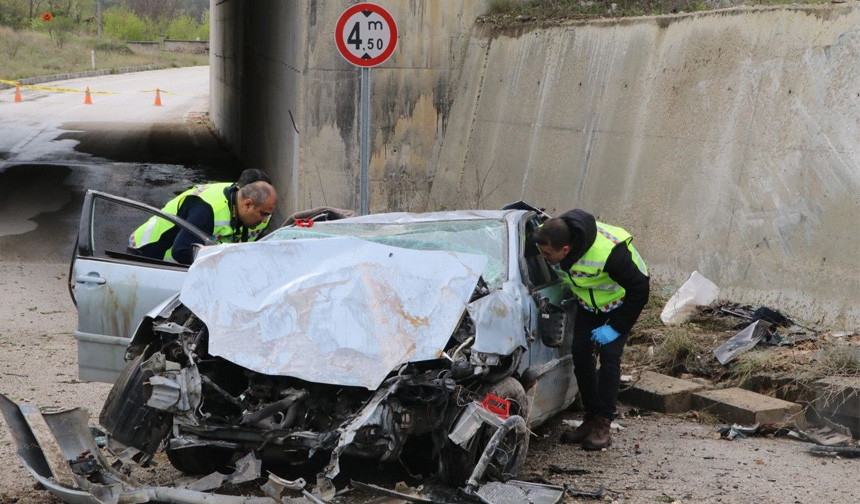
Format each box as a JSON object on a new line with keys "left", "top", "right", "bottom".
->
{"left": 553, "top": 222, "right": 648, "bottom": 312}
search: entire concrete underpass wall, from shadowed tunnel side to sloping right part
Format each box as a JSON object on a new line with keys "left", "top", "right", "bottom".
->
{"left": 211, "top": 0, "right": 860, "bottom": 327}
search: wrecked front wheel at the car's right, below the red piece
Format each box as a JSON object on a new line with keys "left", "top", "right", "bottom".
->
{"left": 442, "top": 377, "right": 530, "bottom": 485}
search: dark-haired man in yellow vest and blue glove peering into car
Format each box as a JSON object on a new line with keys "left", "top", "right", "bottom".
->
{"left": 534, "top": 210, "right": 650, "bottom": 450}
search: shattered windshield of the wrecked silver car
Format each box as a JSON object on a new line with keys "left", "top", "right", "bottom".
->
{"left": 266, "top": 220, "right": 508, "bottom": 288}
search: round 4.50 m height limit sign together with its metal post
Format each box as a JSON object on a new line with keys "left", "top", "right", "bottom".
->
{"left": 335, "top": 3, "right": 397, "bottom": 215}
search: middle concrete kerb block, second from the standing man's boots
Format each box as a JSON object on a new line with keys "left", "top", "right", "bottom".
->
{"left": 693, "top": 388, "right": 806, "bottom": 427}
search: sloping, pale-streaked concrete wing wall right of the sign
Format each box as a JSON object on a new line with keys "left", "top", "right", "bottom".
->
{"left": 429, "top": 3, "right": 860, "bottom": 327}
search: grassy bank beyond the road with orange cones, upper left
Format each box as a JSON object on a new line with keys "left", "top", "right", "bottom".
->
{"left": 0, "top": 26, "right": 209, "bottom": 80}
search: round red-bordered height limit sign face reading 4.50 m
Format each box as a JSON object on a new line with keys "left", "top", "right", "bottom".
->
{"left": 334, "top": 3, "right": 397, "bottom": 67}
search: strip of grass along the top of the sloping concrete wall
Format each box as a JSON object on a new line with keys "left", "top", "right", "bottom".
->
{"left": 485, "top": 0, "right": 830, "bottom": 25}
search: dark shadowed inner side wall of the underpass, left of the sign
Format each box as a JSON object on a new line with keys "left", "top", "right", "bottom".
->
{"left": 209, "top": 0, "right": 312, "bottom": 215}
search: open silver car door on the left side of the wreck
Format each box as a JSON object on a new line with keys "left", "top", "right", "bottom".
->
{"left": 69, "top": 190, "right": 214, "bottom": 383}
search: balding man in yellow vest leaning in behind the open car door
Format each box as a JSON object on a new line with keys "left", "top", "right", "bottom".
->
{"left": 128, "top": 174, "right": 277, "bottom": 264}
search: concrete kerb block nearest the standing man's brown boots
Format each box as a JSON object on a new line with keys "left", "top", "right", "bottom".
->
{"left": 618, "top": 371, "right": 705, "bottom": 413}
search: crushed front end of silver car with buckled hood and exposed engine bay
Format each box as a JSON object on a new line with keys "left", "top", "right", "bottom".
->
{"left": 94, "top": 238, "right": 528, "bottom": 482}
